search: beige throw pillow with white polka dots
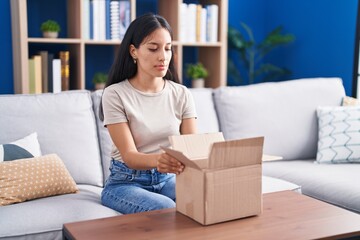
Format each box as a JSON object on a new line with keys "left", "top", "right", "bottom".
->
{"left": 0, "top": 154, "right": 78, "bottom": 206}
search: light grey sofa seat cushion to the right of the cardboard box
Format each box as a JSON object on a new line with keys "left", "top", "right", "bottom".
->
{"left": 263, "top": 159, "right": 360, "bottom": 213}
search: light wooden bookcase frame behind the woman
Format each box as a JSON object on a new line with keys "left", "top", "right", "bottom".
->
{"left": 10, "top": 0, "right": 228, "bottom": 93}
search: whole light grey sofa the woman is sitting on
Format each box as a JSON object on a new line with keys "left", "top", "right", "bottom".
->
{"left": 0, "top": 78, "right": 360, "bottom": 239}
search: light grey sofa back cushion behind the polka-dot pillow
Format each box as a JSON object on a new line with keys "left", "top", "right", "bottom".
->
{"left": 0, "top": 90, "right": 103, "bottom": 186}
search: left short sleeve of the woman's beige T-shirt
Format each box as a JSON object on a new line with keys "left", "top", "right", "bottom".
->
{"left": 102, "top": 85, "right": 128, "bottom": 126}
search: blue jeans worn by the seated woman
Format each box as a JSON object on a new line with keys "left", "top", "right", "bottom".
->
{"left": 101, "top": 160, "right": 175, "bottom": 214}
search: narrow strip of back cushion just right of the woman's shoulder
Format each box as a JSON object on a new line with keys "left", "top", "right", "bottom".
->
{"left": 189, "top": 88, "right": 219, "bottom": 133}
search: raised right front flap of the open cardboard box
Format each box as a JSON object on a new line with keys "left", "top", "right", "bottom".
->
{"left": 208, "top": 137, "right": 264, "bottom": 169}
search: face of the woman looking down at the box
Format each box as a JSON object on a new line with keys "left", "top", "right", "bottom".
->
{"left": 130, "top": 28, "right": 172, "bottom": 78}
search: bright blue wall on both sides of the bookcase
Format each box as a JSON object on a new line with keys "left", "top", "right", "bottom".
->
{"left": 0, "top": 0, "right": 358, "bottom": 95}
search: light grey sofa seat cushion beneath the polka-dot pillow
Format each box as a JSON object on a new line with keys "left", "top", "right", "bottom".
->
{"left": 0, "top": 185, "right": 119, "bottom": 239}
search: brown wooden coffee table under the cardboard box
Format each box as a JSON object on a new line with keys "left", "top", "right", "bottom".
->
{"left": 63, "top": 191, "right": 360, "bottom": 240}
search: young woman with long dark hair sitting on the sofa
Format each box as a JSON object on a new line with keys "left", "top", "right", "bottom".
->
{"left": 100, "top": 14, "right": 196, "bottom": 214}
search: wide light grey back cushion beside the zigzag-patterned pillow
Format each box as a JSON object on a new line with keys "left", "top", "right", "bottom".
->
{"left": 214, "top": 78, "right": 345, "bottom": 160}
